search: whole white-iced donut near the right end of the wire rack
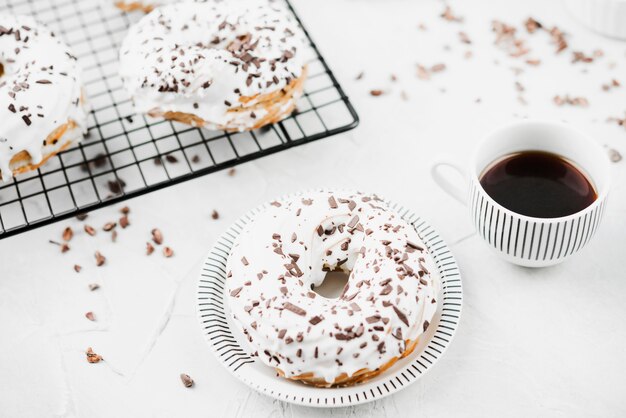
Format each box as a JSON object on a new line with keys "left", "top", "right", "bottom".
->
{"left": 120, "top": 0, "right": 306, "bottom": 131}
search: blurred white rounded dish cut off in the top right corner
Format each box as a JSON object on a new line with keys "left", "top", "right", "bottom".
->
{"left": 563, "top": 0, "right": 626, "bottom": 40}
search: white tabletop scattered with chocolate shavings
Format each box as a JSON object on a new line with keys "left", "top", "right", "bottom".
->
{"left": 0, "top": 0, "right": 626, "bottom": 417}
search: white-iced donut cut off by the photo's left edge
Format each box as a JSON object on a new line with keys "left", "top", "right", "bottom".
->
{"left": 0, "top": 14, "right": 87, "bottom": 182}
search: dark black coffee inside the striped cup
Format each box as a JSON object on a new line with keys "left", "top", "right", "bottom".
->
{"left": 480, "top": 151, "right": 598, "bottom": 218}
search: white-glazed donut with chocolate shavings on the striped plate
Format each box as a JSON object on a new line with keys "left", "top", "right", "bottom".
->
{"left": 226, "top": 191, "right": 439, "bottom": 387}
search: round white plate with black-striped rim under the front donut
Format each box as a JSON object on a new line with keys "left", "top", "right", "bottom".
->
{"left": 197, "top": 194, "right": 463, "bottom": 407}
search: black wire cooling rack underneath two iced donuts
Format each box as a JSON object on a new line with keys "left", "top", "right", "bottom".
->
{"left": 0, "top": 0, "right": 358, "bottom": 239}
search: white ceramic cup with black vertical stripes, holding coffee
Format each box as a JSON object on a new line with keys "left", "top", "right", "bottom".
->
{"left": 431, "top": 121, "right": 610, "bottom": 267}
